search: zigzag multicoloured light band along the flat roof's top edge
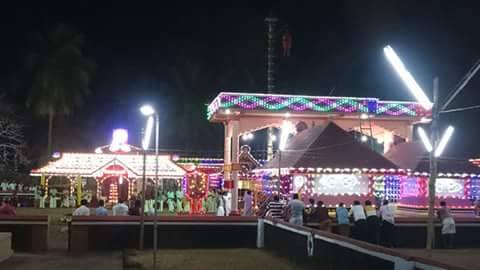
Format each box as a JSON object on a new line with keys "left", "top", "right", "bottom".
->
{"left": 207, "top": 93, "right": 425, "bottom": 119}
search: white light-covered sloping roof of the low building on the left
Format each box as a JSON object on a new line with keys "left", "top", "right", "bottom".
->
{"left": 31, "top": 153, "right": 185, "bottom": 178}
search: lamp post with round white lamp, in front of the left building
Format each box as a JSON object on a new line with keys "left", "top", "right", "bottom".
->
{"left": 140, "top": 105, "right": 163, "bottom": 269}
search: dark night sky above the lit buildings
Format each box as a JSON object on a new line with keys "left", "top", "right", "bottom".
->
{"left": 0, "top": 1, "right": 480, "bottom": 162}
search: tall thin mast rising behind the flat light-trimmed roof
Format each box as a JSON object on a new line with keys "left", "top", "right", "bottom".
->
{"left": 265, "top": 13, "right": 278, "bottom": 160}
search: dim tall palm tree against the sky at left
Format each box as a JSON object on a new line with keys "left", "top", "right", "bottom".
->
{"left": 27, "top": 24, "right": 94, "bottom": 158}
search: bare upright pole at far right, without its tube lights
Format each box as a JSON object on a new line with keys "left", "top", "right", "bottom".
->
{"left": 427, "top": 77, "right": 440, "bottom": 250}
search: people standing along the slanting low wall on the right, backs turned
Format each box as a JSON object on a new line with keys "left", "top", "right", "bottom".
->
{"left": 263, "top": 194, "right": 456, "bottom": 248}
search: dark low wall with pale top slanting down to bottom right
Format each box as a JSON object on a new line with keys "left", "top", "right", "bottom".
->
{"left": 257, "top": 218, "right": 465, "bottom": 270}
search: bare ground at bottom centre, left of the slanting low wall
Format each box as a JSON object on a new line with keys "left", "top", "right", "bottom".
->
{"left": 135, "top": 249, "right": 301, "bottom": 270}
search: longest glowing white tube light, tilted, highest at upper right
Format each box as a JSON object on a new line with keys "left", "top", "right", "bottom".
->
{"left": 383, "top": 45, "right": 433, "bottom": 110}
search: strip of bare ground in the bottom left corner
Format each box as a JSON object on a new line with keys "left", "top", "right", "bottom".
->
{"left": 0, "top": 252, "right": 123, "bottom": 270}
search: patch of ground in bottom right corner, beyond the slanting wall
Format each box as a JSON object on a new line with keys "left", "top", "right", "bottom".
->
{"left": 397, "top": 248, "right": 480, "bottom": 270}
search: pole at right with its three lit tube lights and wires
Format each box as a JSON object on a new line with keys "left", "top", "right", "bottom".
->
{"left": 383, "top": 46, "right": 480, "bottom": 250}
